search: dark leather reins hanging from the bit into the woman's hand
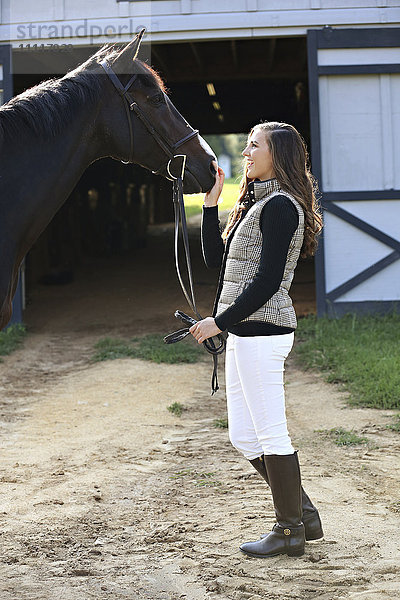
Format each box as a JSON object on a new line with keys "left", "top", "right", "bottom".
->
{"left": 164, "top": 154, "right": 226, "bottom": 394}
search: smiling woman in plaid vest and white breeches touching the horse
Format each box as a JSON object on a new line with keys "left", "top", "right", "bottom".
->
{"left": 190, "top": 122, "right": 323, "bottom": 558}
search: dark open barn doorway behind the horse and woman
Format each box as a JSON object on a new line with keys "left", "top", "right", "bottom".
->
{"left": 14, "top": 37, "right": 315, "bottom": 327}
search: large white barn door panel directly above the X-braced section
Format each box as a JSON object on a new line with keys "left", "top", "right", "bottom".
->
{"left": 320, "top": 72, "right": 400, "bottom": 192}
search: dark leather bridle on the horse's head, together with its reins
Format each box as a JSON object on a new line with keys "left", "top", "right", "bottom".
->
{"left": 100, "top": 60, "right": 226, "bottom": 394}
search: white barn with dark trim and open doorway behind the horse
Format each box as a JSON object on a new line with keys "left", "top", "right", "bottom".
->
{"left": 0, "top": 0, "right": 400, "bottom": 328}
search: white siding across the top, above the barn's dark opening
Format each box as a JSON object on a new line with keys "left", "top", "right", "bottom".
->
{"left": 0, "top": 0, "right": 400, "bottom": 47}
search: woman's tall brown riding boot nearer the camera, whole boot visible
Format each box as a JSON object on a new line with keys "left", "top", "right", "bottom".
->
{"left": 240, "top": 454, "right": 305, "bottom": 558}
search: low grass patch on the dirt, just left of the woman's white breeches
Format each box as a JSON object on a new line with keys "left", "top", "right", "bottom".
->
{"left": 92, "top": 333, "right": 202, "bottom": 364}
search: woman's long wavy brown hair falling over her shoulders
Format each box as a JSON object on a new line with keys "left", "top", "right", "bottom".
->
{"left": 222, "top": 121, "right": 322, "bottom": 258}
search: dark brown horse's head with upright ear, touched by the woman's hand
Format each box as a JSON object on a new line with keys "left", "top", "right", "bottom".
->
{"left": 92, "top": 29, "right": 216, "bottom": 194}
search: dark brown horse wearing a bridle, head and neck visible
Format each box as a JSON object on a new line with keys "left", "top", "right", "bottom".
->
{"left": 0, "top": 29, "right": 216, "bottom": 330}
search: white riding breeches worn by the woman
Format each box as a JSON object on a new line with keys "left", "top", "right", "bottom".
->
{"left": 225, "top": 333, "right": 294, "bottom": 460}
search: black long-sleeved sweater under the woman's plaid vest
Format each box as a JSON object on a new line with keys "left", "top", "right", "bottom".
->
{"left": 205, "top": 195, "right": 299, "bottom": 337}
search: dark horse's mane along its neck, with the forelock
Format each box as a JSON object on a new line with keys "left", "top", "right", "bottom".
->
{"left": 0, "top": 44, "right": 167, "bottom": 143}
